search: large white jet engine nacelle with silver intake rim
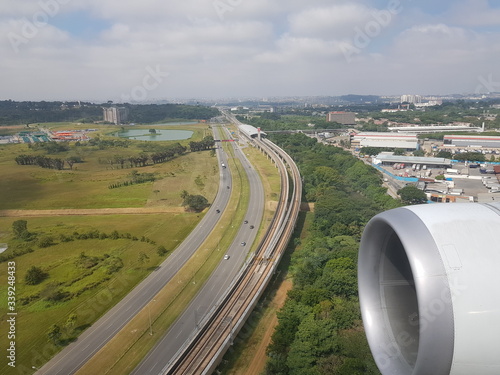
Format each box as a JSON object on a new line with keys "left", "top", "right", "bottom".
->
{"left": 358, "top": 203, "right": 500, "bottom": 375}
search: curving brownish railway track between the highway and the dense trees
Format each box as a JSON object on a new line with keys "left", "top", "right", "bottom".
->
{"left": 161, "top": 131, "right": 302, "bottom": 375}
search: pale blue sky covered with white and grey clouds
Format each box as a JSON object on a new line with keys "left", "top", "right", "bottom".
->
{"left": 0, "top": 0, "right": 500, "bottom": 103}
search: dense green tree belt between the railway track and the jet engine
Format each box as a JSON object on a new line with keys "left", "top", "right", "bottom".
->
{"left": 266, "top": 134, "right": 401, "bottom": 375}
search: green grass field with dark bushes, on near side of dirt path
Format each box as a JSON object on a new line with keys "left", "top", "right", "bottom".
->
{"left": 0, "top": 214, "right": 199, "bottom": 374}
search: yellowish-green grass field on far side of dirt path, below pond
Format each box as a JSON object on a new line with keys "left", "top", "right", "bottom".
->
{"left": 0, "top": 125, "right": 213, "bottom": 210}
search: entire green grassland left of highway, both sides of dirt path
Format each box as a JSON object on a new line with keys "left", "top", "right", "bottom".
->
{"left": 0, "top": 124, "right": 219, "bottom": 374}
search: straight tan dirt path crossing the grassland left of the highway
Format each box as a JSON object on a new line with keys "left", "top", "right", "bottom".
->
{"left": 0, "top": 207, "right": 184, "bottom": 217}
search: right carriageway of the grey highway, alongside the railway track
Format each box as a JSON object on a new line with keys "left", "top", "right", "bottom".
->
{"left": 132, "top": 127, "right": 264, "bottom": 375}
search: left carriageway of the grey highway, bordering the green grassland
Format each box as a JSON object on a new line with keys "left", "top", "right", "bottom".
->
{"left": 36, "top": 128, "right": 239, "bottom": 375}
